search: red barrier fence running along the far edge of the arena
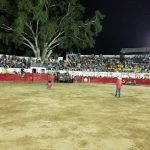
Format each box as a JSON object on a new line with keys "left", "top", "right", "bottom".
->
{"left": 0, "top": 73, "right": 150, "bottom": 86}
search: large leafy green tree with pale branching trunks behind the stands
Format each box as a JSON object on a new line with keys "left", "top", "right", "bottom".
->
{"left": 0, "top": 0, "right": 104, "bottom": 59}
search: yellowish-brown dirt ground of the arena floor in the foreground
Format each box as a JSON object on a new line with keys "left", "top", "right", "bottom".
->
{"left": 0, "top": 83, "right": 150, "bottom": 150}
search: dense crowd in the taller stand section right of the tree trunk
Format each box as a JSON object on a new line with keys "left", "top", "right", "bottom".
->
{"left": 64, "top": 54, "right": 150, "bottom": 72}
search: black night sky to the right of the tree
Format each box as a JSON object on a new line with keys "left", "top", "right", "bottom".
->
{"left": 81, "top": 0, "right": 150, "bottom": 54}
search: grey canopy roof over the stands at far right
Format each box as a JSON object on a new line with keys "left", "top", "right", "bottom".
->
{"left": 120, "top": 47, "right": 150, "bottom": 54}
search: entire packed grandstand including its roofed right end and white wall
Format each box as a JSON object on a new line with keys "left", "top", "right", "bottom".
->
{"left": 0, "top": 48, "right": 150, "bottom": 78}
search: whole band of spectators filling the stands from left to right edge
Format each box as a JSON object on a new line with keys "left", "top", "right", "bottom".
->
{"left": 0, "top": 54, "right": 150, "bottom": 72}
